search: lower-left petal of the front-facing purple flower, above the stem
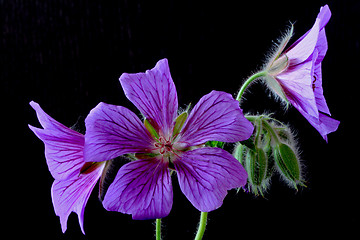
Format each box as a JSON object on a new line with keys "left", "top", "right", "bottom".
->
{"left": 103, "top": 159, "right": 173, "bottom": 220}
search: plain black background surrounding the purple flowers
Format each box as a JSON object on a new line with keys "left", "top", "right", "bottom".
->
{"left": 0, "top": 0, "right": 360, "bottom": 239}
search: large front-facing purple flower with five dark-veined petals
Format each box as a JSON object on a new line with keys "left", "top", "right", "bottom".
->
{"left": 84, "top": 59, "right": 253, "bottom": 219}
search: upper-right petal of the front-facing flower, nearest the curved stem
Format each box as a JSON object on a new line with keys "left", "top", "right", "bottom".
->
{"left": 179, "top": 91, "right": 254, "bottom": 146}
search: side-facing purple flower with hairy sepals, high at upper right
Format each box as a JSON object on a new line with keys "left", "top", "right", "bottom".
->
{"left": 266, "top": 5, "right": 340, "bottom": 141}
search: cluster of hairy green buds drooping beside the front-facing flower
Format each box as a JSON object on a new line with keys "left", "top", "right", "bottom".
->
{"left": 233, "top": 115, "right": 304, "bottom": 195}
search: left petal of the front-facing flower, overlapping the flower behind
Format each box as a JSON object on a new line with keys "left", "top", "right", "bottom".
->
{"left": 84, "top": 103, "right": 152, "bottom": 162}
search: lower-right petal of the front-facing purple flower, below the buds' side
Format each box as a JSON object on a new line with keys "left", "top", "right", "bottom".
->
{"left": 174, "top": 148, "right": 247, "bottom": 212}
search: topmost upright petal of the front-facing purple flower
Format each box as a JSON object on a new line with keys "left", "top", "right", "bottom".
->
{"left": 120, "top": 59, "right": 178, "bottom": 136}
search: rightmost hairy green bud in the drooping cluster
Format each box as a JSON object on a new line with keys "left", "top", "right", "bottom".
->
{"left": 273, "top": 143, "right": 303, "bottom": 189}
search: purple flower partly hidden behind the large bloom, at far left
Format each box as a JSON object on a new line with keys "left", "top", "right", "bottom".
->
{"left": 29, "top": 102, "right": 105, "bottom": 234}
